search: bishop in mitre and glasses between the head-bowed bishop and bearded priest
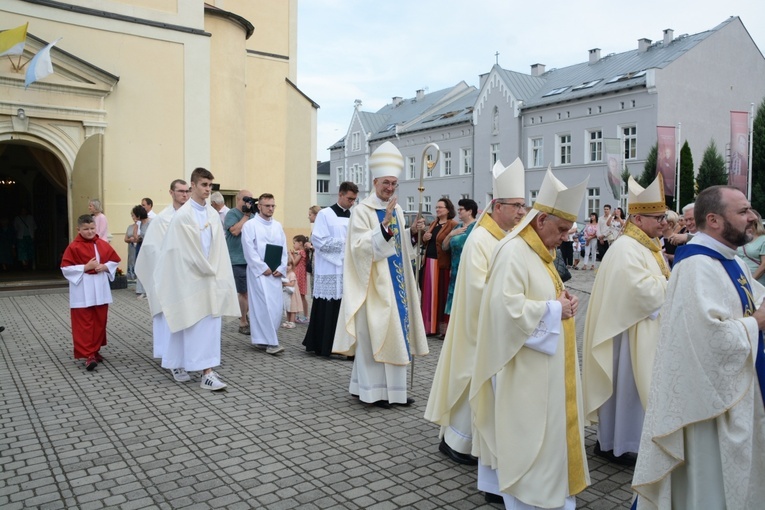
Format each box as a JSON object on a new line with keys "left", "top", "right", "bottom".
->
{"left": 582, "top": 174, "right": 669, "bottom": 465}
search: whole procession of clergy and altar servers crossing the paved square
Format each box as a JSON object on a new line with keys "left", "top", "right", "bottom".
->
{"left": 61, "top": 142, "right": 765, "bottom": 510}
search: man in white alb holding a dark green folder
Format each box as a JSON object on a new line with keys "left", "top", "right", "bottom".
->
{"left": 242, "top": 193, "right": 289, "bottom": 355}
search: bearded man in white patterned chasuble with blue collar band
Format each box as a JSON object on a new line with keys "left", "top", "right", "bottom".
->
{"left": 632, "top": 186, "right": 765, "bottom": 510}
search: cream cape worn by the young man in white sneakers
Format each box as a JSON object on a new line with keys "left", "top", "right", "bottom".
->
{"left": 153, "top": 200, "right": 240, "bottom": 332}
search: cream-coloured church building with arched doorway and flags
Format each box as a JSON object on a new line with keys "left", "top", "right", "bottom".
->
{"left": 0, "top": 0, "right": 318, "bottom": 269}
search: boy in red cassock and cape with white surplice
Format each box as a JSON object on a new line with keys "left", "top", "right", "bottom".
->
{"left": 61, "top": 214, "right": 120, "bottom": 371}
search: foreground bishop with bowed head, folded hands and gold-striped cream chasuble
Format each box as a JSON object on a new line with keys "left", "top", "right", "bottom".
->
{"left": 470, "top": 168, "right": 590, "bottom": 509}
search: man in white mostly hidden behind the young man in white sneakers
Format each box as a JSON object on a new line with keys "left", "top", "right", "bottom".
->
{"left": 135, "top": 179, "right": 189, "bottom": 370}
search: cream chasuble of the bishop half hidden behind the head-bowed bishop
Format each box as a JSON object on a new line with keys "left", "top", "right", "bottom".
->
{"left": 425, "top": 214, "right": 506, "bottom": 454}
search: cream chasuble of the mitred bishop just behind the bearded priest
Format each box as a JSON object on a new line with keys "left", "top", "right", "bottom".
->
{"left": 582, "top": 222, "right": 669, "bottom": 423}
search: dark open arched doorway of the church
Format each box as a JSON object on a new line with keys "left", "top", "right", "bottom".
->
{"left": 0, "top": 141, "right": 69, "bottom": 283}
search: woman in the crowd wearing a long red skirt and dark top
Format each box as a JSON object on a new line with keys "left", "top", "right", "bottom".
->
{"left": 420, "top": 198, "right": 457, "bottom": 335}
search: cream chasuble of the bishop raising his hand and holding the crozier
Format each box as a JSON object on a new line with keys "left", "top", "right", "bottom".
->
{"left": 332, "top": 194, "right": 428, "bottom": 365}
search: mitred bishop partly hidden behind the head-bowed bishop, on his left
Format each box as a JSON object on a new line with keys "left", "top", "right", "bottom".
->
{"left": 425, "top": 158, "right": 526, "bottom": 478}
